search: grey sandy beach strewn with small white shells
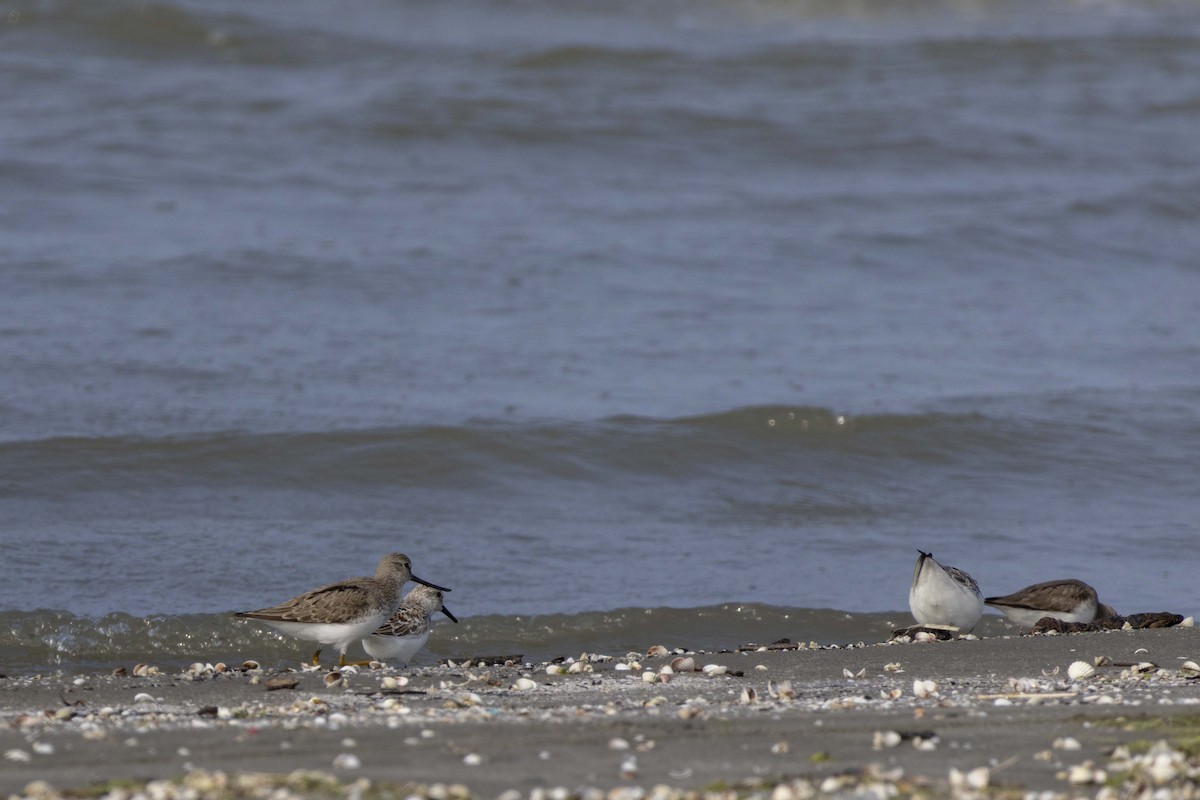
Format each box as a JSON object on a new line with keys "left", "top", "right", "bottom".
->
{"left": 0, "top": 627, "right": 1200, "bottom": 800}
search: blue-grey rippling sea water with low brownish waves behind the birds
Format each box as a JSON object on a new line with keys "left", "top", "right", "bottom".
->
{"left": 0, "top": 0, "right": 1200, "bottom": 673}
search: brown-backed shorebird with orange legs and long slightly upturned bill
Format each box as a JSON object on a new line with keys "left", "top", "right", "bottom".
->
{"left": 234, "top": 553, "right": 450, "bottom": 667}
